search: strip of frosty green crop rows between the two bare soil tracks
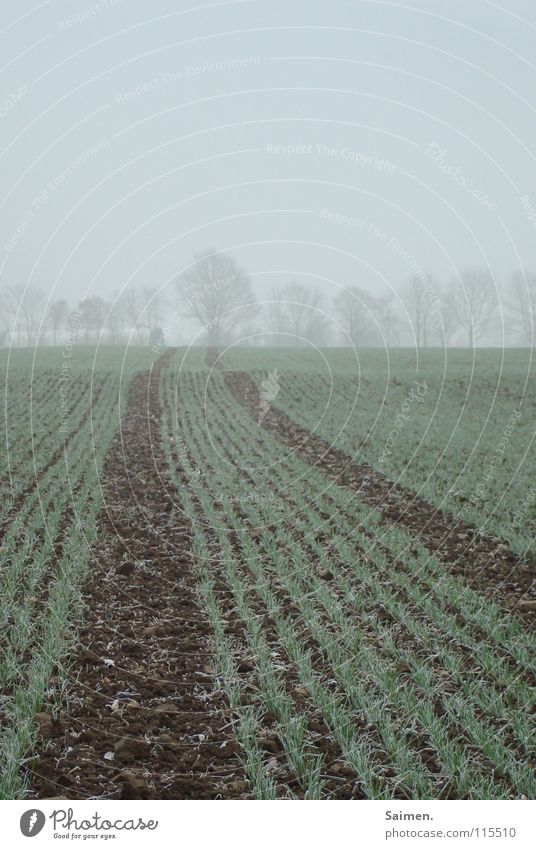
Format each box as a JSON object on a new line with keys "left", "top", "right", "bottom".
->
{"left": 158, "top": 362, "right": 532, "bottom": 798}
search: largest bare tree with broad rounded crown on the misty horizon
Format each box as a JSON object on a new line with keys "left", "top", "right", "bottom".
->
{"left": 177, "top": 251, "right": 257, "bottom": 348}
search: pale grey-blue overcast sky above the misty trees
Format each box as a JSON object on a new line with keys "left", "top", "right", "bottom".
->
{"left": 0, "top": 0, "right": 536, "bottom": 328}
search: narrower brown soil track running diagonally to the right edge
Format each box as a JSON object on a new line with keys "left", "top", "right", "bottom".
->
{"left": 225, "top": 371, "right": 536, "bottom": 627}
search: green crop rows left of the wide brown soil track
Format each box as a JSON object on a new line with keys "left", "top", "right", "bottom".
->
{"left": 0, "top": 350, "right": 153, "bottom": 799}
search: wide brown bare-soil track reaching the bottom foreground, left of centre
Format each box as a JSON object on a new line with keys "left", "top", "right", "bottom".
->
{"left": 26, "top": 349, "right": 247, "bottom": 799}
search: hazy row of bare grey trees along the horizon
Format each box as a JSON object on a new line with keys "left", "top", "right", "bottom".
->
{"left": 0, "top": 251, "right": 536, "bottom": 348}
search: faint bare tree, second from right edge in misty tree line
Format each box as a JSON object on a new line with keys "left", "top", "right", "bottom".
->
{"left": 444, "top": 268, "right": 497, "bottom": 348}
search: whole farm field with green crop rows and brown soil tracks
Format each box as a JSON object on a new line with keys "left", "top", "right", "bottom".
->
{"left": 0, "top": 348, "right": 536, "bottom": 799}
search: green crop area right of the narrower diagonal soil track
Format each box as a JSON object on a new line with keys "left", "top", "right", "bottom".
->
{"left": 253, "top": 362, "right": 536, "bottom": 556}
